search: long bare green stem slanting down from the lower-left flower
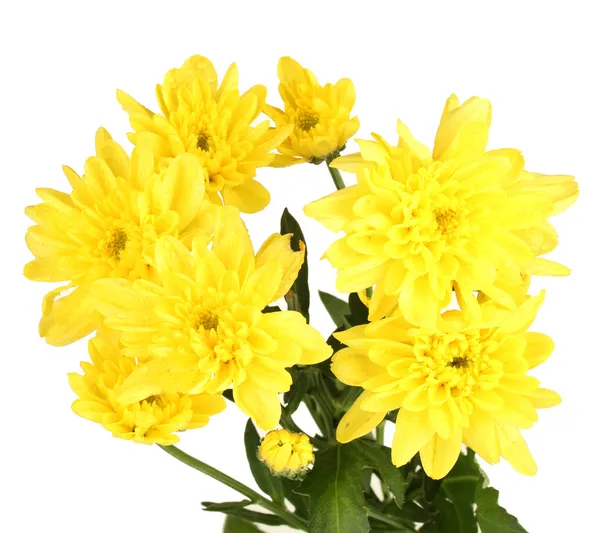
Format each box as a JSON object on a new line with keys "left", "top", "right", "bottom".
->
{"left": 159, "top": 444, "right": 308, "bottom": 531}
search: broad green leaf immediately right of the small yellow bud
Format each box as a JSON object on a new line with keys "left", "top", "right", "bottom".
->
{"left": 298, "top": 442, "right": 369, "bottom": 533}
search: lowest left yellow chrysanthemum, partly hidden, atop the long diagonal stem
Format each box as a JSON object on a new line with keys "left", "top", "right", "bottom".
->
{"left": 69, "top": 332, "right": 225, "bottom": 445}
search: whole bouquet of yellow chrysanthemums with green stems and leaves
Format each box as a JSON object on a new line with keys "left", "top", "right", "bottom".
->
{"left": 25, "top": 56, "right": 578, "bottom": 533}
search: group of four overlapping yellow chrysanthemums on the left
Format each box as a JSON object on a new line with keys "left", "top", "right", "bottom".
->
{"left": 24, "top": 56, "right": 338, "bottom": 445}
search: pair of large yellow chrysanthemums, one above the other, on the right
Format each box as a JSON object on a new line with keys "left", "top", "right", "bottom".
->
{"left": 305, "top": 95, "right": 578, "bottom": 479}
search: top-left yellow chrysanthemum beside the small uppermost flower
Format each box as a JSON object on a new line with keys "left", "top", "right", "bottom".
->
{"left": 117, "top": 55, "right": 291, "bottom": 213}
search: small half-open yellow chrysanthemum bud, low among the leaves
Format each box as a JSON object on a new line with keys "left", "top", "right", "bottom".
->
{"left": 258, "top": 429, "right": 315, "bottom": 479}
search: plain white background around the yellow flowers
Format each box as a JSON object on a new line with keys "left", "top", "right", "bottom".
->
{"left": 0, "top": 0, "right": 600, "bottom": 533}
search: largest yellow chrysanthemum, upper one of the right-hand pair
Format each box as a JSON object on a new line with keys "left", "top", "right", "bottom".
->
{"left": 305, "top": 96, "right": 577, "bottom": 327}
